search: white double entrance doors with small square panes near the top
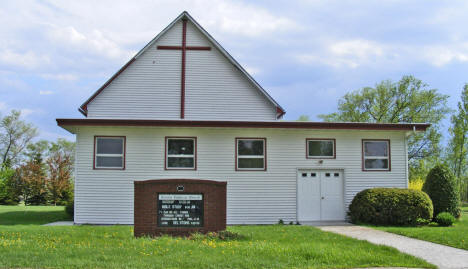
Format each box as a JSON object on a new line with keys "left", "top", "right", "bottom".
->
{"left": 297, "top": 170, "right": 345, "bottom": 221}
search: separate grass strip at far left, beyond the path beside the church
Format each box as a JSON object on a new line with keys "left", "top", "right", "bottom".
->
{"left": 0, "top": 205, "right": 70, "bottom": 225}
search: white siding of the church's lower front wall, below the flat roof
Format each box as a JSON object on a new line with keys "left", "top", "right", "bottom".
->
{"left": 75, "top": 127, "right": 407, "bottom": 224}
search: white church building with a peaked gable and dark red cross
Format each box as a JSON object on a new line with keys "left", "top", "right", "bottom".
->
{"left": 57, "top": 12, "right": 429, "bottom": 224}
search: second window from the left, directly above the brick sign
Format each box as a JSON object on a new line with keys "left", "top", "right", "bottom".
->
{"left": 166, "top": 137, "right": 197, "bottom": 170}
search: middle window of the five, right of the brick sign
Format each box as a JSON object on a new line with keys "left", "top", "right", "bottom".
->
{"left": 236, "top": 138, "right": 266, "bottom": 171}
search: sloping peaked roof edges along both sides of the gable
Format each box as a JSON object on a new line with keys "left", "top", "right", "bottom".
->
{"left": 78, "top": 11, "right": 286, "bottom": 119}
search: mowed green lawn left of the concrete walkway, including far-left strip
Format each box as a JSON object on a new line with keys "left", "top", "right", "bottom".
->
{"left": 0, "top": 206, "right": 434, "bottom": 269}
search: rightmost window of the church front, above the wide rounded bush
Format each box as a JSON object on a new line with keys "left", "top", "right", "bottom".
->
{"left": 362, "top": 140, "right": 390, "bottom": 171}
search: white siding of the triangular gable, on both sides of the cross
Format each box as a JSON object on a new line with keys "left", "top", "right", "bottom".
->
{"left": 88, "top": 21, "right": 276, "bottom": 121}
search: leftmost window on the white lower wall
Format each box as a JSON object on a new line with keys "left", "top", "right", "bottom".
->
{"left": 94, "top": 136, "right": 125, "bottom": 170}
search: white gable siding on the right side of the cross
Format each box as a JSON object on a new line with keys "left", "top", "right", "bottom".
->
{"left": 186, "top": 23, "right": 276, "bottom": 121}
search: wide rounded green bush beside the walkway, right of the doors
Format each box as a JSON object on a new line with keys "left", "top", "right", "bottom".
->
{"left": 349, "top": 188, "right": 433, "bottom": 226}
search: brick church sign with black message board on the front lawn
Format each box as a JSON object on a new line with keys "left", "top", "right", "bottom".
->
{"left": 134, "top": 179, "right": 226, "bottom": 236}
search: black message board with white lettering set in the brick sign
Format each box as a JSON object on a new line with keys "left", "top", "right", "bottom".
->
{"left": 158, "top": 193, "right": 203, "bottom": 227}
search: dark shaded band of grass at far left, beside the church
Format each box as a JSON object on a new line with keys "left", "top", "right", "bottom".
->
{"left": 0, "top": 210, "right": 71, "bottom": 225}
